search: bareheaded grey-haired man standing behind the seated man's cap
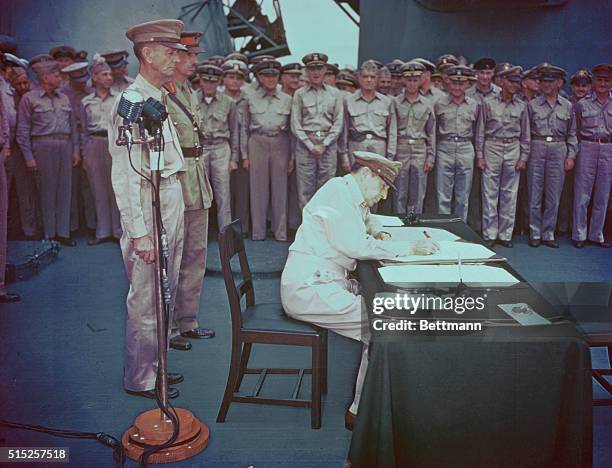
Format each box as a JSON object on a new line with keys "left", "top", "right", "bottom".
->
{"left": 339, "top": 61, "right": 397, "bottom": 172}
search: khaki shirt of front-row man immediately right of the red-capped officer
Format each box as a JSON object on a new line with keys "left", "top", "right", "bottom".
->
{"left": 197, "top": 91, "right": 240, "bottom": 161}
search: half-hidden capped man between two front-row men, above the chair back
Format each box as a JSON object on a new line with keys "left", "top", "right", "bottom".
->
{"left": 221, "top": 59, "right": 251, "bottom": 235}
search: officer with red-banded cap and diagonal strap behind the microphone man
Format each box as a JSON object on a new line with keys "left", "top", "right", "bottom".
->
{"left": 166, "top": 32, "right": 215, "bottom": 351}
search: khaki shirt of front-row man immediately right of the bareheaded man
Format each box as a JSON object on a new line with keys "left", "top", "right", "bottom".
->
{"left": 395, "top": 93, "right": 436, "bottom": 164}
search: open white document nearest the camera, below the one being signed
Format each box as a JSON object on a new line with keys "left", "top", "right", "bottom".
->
{"left": 378, "top": 264, "right": 519, "bottom": 287}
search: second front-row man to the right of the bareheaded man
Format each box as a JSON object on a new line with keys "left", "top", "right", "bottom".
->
{"left": 434, "top": 65, "right": 480, "bottom": 221}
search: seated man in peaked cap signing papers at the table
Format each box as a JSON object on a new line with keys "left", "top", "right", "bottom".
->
{"left": 281, "top": 151, "right": 439, "bottom": 429}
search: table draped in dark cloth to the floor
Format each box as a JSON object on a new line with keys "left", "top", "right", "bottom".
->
{"left": 348, "top": 221, "right": 592, "bottom": 468}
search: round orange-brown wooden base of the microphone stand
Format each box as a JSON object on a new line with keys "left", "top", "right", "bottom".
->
{"left": 121, "top": 408, "right": 210, "bottom": 464}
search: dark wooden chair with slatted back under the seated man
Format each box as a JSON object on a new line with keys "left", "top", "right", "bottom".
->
{"left": 217, "top": 220, "right": 327, "bottom": 429}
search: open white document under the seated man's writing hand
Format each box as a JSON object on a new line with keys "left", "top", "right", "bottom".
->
{"left": 380, "top": 239, "right": 505, "bottom": 265}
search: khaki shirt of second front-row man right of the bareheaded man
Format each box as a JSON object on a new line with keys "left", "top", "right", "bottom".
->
{"left": 434, "top": 95, "right": 480, "bottom": 141}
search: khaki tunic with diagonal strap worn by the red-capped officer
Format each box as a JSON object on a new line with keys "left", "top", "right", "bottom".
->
{"left": 167, "top": 81, "right": 213, "bottom": 211}
